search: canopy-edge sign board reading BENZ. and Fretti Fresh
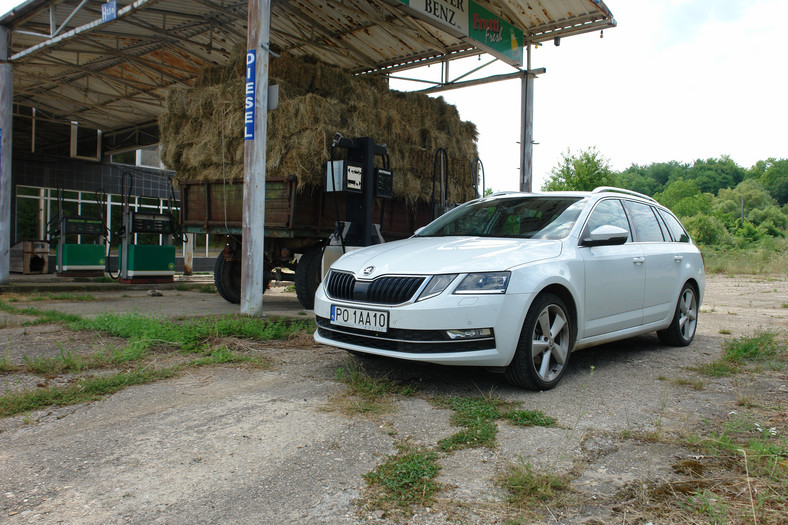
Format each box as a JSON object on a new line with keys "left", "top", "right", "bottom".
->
{"left": 400, "top": 0, "right": 523, "bottom": 66}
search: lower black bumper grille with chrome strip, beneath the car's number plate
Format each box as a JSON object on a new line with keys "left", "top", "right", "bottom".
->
{"left": 315, "top": 316, "right": 495, "bottom": 354}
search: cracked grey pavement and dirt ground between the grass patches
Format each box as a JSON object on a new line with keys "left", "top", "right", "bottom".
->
{"left": 0, "top": 276, "right": 788, "bottom": 525}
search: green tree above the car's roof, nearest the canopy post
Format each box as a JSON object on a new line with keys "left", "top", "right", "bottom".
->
{"left": 542, "top": 148, "right": 616, "bottom": 191}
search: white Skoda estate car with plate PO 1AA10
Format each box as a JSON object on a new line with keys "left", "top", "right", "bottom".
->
{"left": 315, "top": 187, "right": 706, "bottom": 390}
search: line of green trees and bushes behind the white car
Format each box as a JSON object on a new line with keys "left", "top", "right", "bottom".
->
{"left": 542, "top": 148, "right": 788, "bottom": 248}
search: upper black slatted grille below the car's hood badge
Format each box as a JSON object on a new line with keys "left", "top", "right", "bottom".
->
{"left": 326, "top": 271, "right": 426, "bottom": 305}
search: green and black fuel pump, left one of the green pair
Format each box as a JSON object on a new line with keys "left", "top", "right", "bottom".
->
{"left": 50, "top": 188, "right": 107, "bottom": 277}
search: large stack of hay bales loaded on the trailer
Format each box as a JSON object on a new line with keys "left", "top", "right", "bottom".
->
{"left": 159, "top": 53, "right": 478, "bottom": 202}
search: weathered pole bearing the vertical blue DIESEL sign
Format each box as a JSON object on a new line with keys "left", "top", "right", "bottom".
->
{"left": 241, "top": 0, "right": 271, "bottom": 316}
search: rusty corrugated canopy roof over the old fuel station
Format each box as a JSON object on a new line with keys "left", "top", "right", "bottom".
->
{"left": 0, "top": 0, "right": 615, "bottom": 149}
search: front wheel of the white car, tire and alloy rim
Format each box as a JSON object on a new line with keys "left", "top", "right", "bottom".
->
{"left": 506, "top": 294, "right": 573, "bottom": 390}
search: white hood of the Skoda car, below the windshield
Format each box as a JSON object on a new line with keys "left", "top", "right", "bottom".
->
{"left": 332, "top": 237, "right": 561, "bottom": 279}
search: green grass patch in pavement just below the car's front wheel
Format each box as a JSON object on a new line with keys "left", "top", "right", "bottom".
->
{"left": 432, "top": 396, "right": 555, "bottom": 452}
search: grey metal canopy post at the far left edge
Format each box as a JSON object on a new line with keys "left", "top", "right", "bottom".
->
{"left": 0, "top": 26, "right": 14, "bottom": 284}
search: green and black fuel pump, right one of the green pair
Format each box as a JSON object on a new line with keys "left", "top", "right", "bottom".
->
{"left": 118, "top": 172, "right": 175, "bottom": 284}
